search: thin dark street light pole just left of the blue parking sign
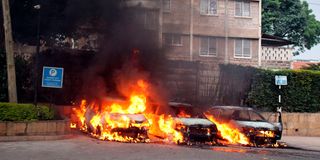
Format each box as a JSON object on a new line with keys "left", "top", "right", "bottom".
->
{"left": 34, "top": 4, "right": 41, "bottom": 106}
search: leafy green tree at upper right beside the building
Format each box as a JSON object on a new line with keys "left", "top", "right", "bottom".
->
{"left": 262, "top": 0, "right": 320, "bottom": 54}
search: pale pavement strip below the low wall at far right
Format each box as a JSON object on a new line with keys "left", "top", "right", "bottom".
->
{"left": 282, "top": 136, "right": 320, "bottom": 151}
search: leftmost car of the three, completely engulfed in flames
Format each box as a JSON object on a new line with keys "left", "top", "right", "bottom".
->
{"left": 71, "top": 80, "right": 150, "bottom": 142}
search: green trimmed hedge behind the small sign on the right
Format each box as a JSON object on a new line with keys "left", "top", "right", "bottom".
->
{"left": 248, "top": 70, "right": 320, "bottom": 112}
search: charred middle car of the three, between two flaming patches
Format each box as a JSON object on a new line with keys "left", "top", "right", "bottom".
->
{"left": 169, "top": 102, "right": 217, "bottom": 145}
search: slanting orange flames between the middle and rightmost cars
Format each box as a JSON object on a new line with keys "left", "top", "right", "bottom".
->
{"left": 206, "top": 114, "right": 249, "bottom": 145}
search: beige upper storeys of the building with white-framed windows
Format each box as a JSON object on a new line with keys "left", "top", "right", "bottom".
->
{"left": 160, "top": 0, "right": 261, "bottom": 67}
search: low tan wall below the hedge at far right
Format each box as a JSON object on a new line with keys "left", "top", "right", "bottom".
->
{"left": 263, "top": 113, "right": 320, "bottom": 136}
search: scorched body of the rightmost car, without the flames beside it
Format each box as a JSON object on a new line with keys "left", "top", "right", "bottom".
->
{"left": 206, "top": 106, "right": 282, "bottom": 146}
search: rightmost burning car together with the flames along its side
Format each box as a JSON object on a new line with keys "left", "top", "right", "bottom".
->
{"left": 205, "top": 106, "right": 282, "bottom": 146}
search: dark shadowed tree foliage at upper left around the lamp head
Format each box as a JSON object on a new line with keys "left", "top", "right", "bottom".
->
{"left": 4, "top": 0, "right": 121, "bottom": 44}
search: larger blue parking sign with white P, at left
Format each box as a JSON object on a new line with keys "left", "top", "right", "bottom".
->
{"left": 42, "top": 66, "right": 63, "bottom": 88}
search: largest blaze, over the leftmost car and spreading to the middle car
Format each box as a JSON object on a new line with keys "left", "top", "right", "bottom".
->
{"left": 71, "top": 80, "right": 183, "bottom": 142}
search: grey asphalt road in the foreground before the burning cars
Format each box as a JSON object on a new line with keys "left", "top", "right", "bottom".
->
{"left": 0, "top": 135, "right": 320, "bottom": 160}
